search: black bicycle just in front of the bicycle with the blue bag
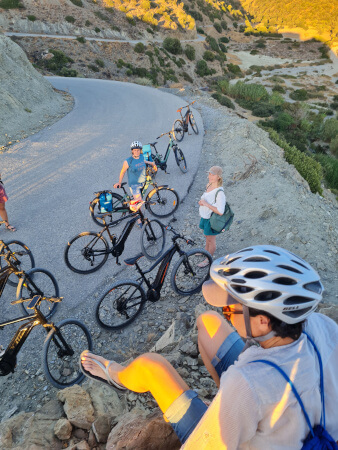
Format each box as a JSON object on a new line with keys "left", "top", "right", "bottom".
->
{"left": 64, "top": 205, "right": 165, "bottom": 274}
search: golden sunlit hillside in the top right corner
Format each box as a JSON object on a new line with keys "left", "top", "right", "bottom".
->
{"left": 241, "top": 0, "right": 338, "bottom": 47}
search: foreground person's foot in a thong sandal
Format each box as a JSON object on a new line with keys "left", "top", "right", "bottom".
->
{"left": 81, "top": 350, "right": 126, "bottom": 390}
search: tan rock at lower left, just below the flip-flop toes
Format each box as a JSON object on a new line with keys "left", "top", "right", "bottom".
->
{"left": 57, "top": 385, "right": 95, "bottom": 430}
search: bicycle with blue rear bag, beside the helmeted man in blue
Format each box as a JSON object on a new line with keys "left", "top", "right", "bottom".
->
{"left": 89, "top": 177, "right": 180, "bottom": 227}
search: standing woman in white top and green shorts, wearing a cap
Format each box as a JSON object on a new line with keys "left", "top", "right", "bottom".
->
{"left": 198, "top": 166, "right": 226, "bottom": 267}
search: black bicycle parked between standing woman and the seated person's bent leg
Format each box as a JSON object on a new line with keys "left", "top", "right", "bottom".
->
{"left": 95, "top": 226, "right": 212, "bottom": 330}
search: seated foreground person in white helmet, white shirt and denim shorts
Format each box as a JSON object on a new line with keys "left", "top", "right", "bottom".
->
{"left": 80, "top": 245, "right": 338, "bottom": 450}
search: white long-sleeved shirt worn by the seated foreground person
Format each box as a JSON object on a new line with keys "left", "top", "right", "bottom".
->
{"left": 182, "top": 313, "right": 338, "bottom": 450}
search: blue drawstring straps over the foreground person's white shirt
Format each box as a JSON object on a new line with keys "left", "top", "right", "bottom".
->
{"left": 250, "top": 331, "right": 325, "bottom": 437}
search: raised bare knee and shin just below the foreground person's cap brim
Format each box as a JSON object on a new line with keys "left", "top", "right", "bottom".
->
{"left": 197, "top": 311, "right": 234, "bottom": 387}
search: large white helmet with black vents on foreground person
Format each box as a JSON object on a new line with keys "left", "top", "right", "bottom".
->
{"left": 210, "top": 245, "right": 324, "bottom": 324}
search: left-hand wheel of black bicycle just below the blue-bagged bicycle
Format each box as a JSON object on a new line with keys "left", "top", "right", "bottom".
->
{"left": 64, "top": 231, "right": 109, "bottom": 274}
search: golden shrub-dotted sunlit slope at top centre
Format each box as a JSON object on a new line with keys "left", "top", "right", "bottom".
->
{"left": 102, "top": 0, "right": 195, "bottom": 30}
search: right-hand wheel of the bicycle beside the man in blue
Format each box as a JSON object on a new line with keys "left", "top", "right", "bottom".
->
{"left": 146, "top": 186, "right": 180, "bottom": 217}
